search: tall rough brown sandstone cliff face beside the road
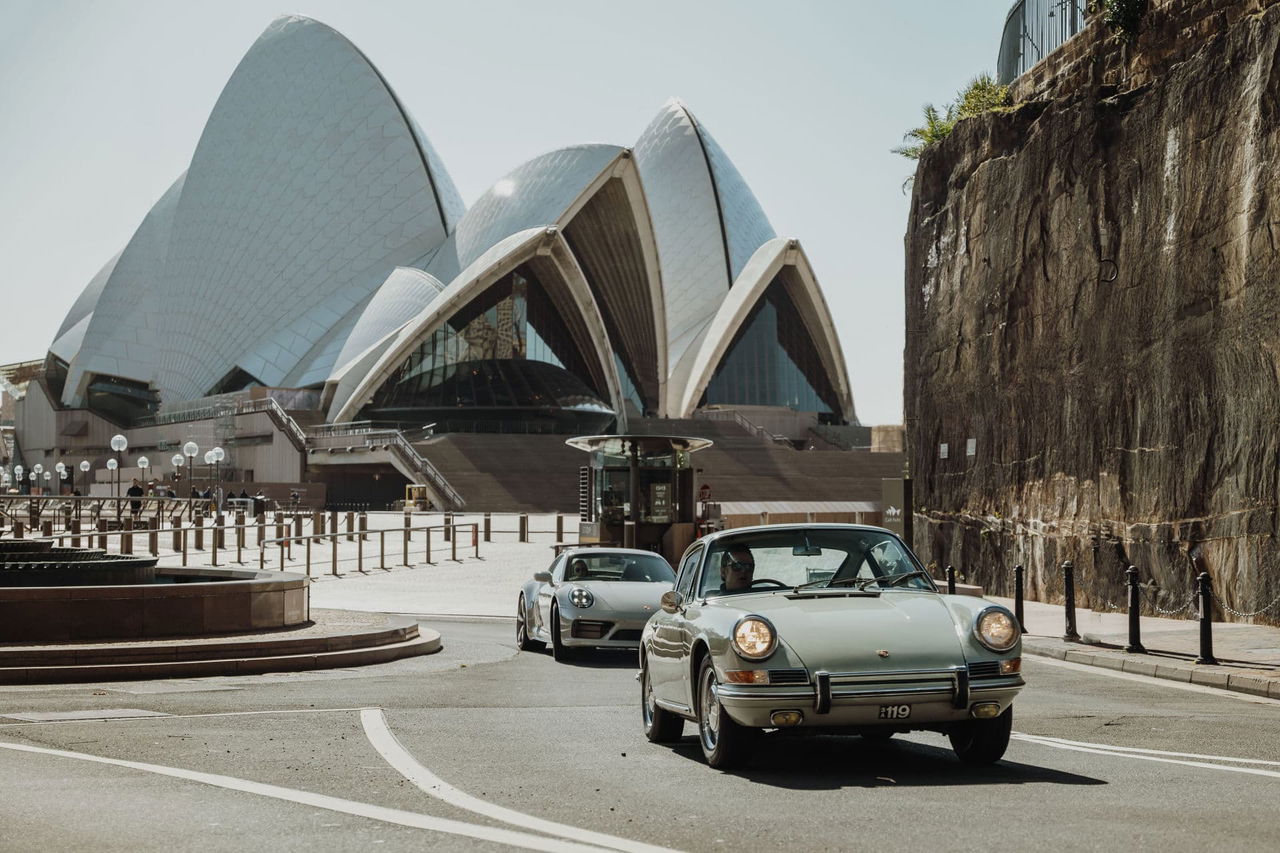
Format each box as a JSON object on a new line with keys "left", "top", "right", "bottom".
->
{"left": 905, "top": 3, "right": 1280, "bottom": 622}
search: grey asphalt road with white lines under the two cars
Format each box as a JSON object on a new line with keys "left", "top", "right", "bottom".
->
{"left": 0, "top": 620, "right": 1280, "bottom": 852}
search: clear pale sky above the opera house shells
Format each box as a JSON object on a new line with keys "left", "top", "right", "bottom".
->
{"left": 0, "top": 0, "right": 1011, "bottom": 424}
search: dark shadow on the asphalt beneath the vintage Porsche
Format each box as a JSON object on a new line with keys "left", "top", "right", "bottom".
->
{"left": 675, "top": 724, "right": 1107, "bottom": 790}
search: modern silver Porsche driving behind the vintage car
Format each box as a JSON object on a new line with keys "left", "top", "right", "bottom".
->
{"left": 516, "top": 547, "right": 676, "bottom": 661}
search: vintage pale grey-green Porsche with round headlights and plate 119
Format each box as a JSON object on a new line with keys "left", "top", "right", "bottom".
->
{"left": 639, "top": 524, "right": 1023, "bottom": 767}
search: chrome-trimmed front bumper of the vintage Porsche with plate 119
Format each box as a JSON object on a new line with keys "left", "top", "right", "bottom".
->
{"left": 716, "top": 667, "right": 1025, "bottom": 729}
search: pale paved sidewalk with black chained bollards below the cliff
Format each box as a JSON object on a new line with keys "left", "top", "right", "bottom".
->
{"left": 987, "top": 596, "right": 1280, "bottom": 699}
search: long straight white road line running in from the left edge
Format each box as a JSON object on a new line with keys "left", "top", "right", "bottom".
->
{"left": 0, "top": 742, "right": 600, "bottom": 853}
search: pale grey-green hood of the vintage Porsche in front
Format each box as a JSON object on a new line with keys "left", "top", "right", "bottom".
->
{"left": 737, "top": 592, "right": 965, "bottom": 672}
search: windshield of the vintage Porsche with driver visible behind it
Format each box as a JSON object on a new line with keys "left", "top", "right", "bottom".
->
{"left": 701, "top": 528, "right": 934, "bottom": 596}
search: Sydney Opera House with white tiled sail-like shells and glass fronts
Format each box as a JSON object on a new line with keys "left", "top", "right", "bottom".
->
{"left": 5, "top": 17, "right": 885, "bottom": 507}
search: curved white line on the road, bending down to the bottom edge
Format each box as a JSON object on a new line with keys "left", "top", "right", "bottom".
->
{"left": 360, "top": 708, "right": 669, "bottom": 853}
